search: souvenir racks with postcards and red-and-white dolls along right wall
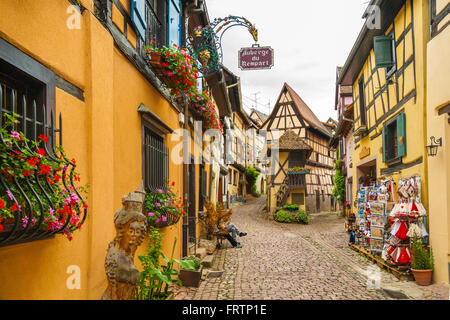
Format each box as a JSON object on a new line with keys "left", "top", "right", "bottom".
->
{"left": 350, "top": 176, "right": 428, "bottom": 276}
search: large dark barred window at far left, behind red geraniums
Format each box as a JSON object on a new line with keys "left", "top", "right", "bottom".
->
{"left": 0, "top": 38, "right": 87, "bottom": 246}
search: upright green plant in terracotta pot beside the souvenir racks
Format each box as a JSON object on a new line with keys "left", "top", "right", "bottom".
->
{"left": 411, "top": 237, "right": 434, "bottom": 286}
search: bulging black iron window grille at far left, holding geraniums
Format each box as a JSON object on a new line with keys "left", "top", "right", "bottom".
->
{"left": 0, "top": 84, "right": 87, "bottom": 246}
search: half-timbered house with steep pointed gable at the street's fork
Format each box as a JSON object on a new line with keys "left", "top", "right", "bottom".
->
{"left": 261, "top": 83, "right": 335, "bottom": 212}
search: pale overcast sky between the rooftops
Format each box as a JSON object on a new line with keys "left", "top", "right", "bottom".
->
{"left": 206, "top": 0, "right": 369, "bottom": 121}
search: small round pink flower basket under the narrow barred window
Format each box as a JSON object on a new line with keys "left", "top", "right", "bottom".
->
{"left": 143, "top": 182, "right": 186, "bottom": 228}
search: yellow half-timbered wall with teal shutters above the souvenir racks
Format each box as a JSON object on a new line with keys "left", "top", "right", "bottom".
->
{"left": 353, "top": 1, "right": 428, "bottom": 207}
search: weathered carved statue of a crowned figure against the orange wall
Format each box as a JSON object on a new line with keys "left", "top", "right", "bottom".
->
{"left": 102, "top": 183, "right": 147, "bottom": 300}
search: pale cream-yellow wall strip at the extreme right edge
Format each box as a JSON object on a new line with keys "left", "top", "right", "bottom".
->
{"left": 427, "top": 28, "right": 450, "bottom": 283}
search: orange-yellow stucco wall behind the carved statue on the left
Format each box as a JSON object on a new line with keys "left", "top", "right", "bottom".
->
{"left": 0, "top": 0, "right": 188, "bottom": 299}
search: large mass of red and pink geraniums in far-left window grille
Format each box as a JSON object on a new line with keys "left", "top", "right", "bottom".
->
{"left": 0, "top": 114, "right": 88, "bottom": 240}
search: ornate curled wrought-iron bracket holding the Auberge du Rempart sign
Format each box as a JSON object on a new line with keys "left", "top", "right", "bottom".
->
{"left": 187, "top": 15, "right": 259, "bottom": 77}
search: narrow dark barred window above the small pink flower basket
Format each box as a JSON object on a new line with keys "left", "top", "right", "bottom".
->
{"left": 143, "top": 127, "right": 169, "bottom": 191}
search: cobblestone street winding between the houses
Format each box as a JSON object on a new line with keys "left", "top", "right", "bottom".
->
{"left": 174, "top": 198, "right": 449, "bottom": 300}
